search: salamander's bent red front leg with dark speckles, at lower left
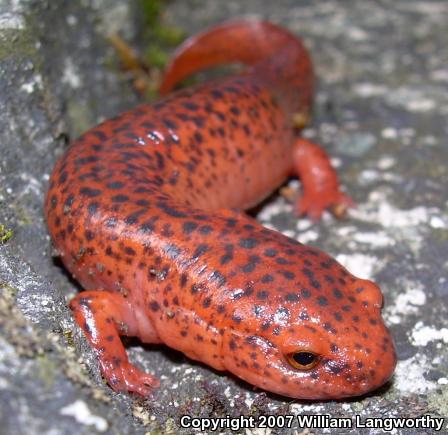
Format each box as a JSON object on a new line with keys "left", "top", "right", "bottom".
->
{"left": 70, "top": 291, "right": 159, "bottom": 397}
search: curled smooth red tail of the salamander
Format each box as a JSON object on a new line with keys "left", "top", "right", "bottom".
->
{"left": 159, "top": 19, "right": 313, "bottom": 106}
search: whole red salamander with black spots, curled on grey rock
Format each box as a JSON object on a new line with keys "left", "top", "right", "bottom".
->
{"left": 45, "top": 21, "right": 395, "bottom": 399}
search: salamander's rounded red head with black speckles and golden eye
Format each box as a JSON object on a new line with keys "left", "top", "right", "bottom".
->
{"left": 220, "top": 247, "right": 396, "bottom": 399}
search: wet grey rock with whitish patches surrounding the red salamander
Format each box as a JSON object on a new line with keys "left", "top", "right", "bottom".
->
{"left": 0, "top": 0, "right": 448, "bottom": 434}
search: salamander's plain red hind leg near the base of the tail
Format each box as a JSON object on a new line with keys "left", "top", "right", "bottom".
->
{"left": 293, "top": 138, "right": 353, "bottom": 220}
